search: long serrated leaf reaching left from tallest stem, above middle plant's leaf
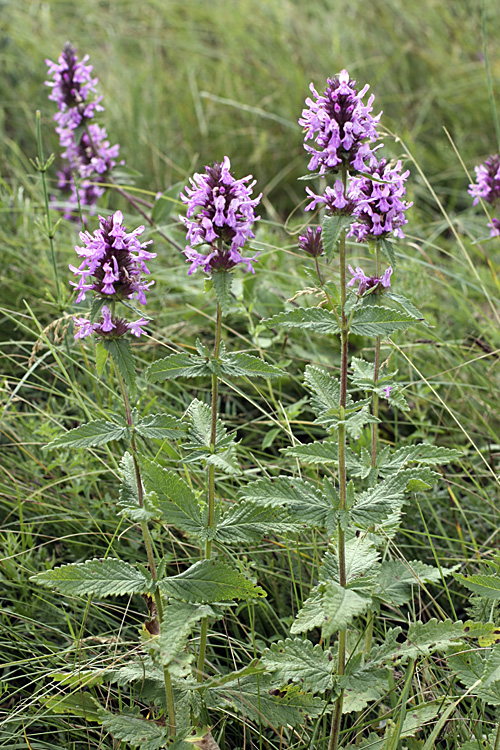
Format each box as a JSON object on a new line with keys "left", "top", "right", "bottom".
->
{"left": 240, "top": 476, "right": 334, "bottom": 527}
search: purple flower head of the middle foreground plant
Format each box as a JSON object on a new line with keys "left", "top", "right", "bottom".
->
{"left": 180, "top": 156, "right": 262, "bottom": 274}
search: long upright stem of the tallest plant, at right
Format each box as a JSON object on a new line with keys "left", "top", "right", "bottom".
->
{"left": 329, "top": 164, "right": 349, "bottom": 750}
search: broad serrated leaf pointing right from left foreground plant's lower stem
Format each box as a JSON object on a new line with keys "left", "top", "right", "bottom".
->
{"left": 158, "top": 560, "right": 266, "bottom": 604}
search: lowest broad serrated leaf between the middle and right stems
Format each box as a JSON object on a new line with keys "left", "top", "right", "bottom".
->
{"left": 207, "top": 675, "right": 325, "bottom": 729}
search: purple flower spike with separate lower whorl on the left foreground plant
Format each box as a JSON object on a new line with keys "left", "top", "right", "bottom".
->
{"left": 69, "top": 211, "right": 156, "bottom": 338}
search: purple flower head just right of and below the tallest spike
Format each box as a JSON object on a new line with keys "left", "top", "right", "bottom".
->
{"left": 349, "top": 159, "right": 413, "bottom": 242}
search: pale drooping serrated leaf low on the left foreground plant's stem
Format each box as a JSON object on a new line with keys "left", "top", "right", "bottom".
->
{"left": 144, "top": 601, "right": 215, "bottom": 667}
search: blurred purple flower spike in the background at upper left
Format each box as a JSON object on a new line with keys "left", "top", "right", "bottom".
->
{"left": 45, "top": 42, "right": 120, "bottom": 218}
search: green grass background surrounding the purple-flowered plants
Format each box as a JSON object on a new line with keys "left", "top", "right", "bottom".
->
{"left": 0, "top": 0, "right": 500, "bottom": 750}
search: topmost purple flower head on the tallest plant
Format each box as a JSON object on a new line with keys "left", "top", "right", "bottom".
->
{"left": 299, "top": 70, "right": 382, "bottom": 175}
